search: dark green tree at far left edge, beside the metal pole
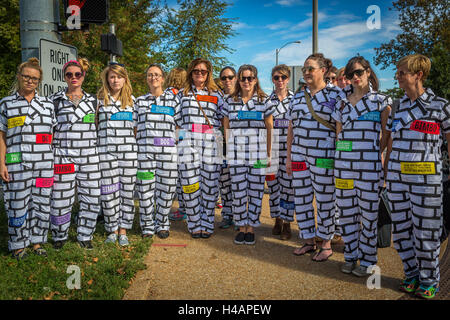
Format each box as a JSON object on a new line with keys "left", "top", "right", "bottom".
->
{"left": 0, "top": 0, "right": 22, "bottom": 99}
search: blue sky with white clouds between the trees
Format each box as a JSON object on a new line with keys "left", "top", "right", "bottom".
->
{"left": 168, "top": 0, "right": 401, "bottom": 93}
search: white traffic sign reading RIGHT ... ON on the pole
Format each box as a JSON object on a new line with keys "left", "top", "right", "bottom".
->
{"left": 39, "top": 39, "right": 78, "bottom": 97}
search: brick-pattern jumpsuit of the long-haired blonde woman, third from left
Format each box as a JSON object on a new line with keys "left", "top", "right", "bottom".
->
{"left": 97, "top": 96, "right": 137, "bottom": 233}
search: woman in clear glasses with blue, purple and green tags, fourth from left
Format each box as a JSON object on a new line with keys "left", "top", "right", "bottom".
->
{"left": 135, "top": 64, "right": 179, "bottom": 239}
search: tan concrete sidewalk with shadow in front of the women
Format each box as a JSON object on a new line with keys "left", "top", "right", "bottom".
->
{"left": 124, "top": 195, "right": 426, "bottom": 300}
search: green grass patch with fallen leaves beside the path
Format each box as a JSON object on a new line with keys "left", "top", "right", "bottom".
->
{"left": 0, "top": 201, "right": 152, "bottom": 300}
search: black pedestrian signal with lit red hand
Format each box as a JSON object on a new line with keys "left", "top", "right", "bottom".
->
{"left": 64, "top": 0, "right": 109, "bottom": 24}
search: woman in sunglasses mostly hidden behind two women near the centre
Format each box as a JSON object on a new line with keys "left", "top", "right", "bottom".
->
{"left": 219, "top": 66, "right": 236, "bottom": 229}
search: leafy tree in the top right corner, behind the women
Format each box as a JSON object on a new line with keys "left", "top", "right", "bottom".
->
{"left": 374, "top": 0, "right": 450, "bottom": 99}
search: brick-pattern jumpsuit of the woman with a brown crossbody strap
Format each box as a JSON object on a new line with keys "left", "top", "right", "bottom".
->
{"left": 288, "top": 87, "right": 340, "bottom": 240}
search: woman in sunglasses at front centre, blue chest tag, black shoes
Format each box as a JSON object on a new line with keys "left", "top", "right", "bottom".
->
{"left": 222, "top": 65, "right": 275, "bottom": 245}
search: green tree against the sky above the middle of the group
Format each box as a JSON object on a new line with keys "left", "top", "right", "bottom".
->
{"left": 160, "top": 0, "right": 236, "bottom": 72}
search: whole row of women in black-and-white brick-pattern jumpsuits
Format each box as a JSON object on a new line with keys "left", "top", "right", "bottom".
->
{"left": 0, "top": 50, "right": 450, "bottom": 298}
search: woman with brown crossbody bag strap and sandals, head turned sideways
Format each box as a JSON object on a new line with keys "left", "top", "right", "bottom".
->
{"left": 286, "top": 53, "right": 340, "bottom": 262}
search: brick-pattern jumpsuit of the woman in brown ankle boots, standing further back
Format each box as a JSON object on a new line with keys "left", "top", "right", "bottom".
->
{"left": 266, "top": 91, "right": 295, "bottom": 222}
